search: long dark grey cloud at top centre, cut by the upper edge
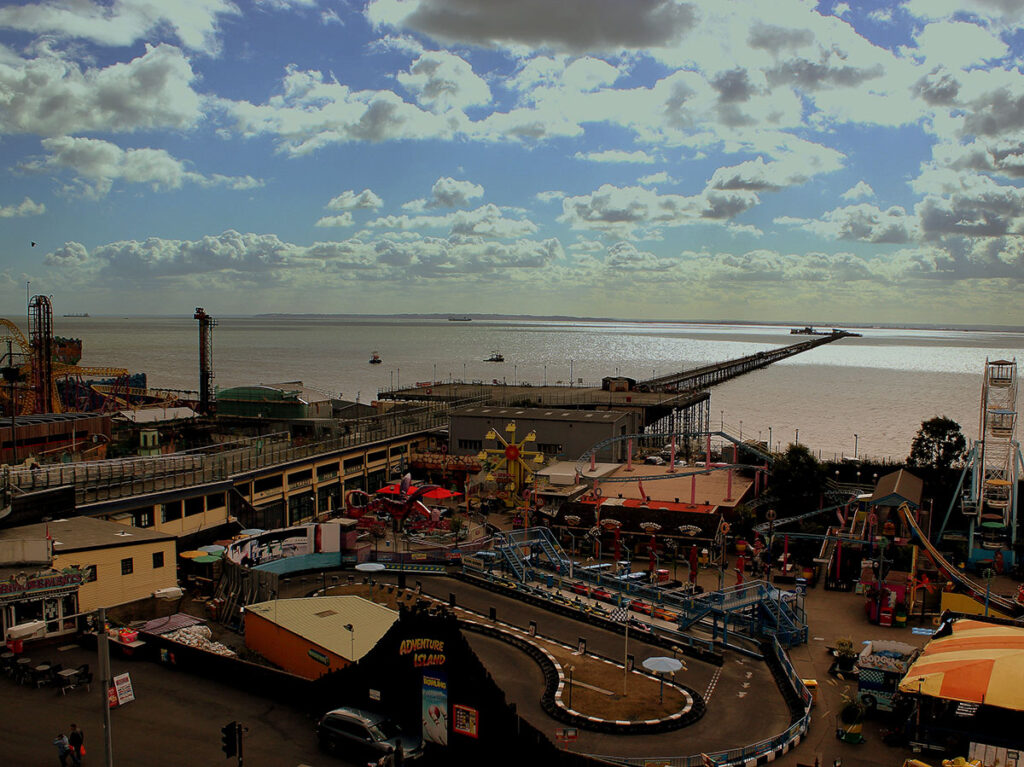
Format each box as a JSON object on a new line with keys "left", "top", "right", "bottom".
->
{"left": 366, "top": 0, "right": 696, "bottom": 51}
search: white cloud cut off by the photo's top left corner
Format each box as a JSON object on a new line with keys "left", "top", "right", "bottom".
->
{"left": 0, "top": 0, "right": 239, "bottom": 53}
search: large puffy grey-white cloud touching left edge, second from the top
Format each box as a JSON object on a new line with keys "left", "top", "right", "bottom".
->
{"left": 0, "top": 45, "right": 201, "bottom": 136}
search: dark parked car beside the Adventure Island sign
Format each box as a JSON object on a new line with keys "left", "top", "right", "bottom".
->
{"left": 316, "top": 707, "right": 423, "bottom": 763}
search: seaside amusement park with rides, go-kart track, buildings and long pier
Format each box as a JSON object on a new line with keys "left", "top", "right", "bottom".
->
{"left": 0, "top": 305, "right": 1024, "bottom": 767}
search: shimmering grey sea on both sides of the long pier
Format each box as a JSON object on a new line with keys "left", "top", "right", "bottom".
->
{"left": 54, "top": 317, "right": 1024, "bottom": 458}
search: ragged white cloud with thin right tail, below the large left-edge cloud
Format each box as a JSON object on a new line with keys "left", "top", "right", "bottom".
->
{"left": 25, "top": 136, "right": 263, "bottom": 199}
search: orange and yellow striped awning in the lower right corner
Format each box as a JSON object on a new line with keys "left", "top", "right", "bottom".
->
{"left": 899, "top": 619, "right": 1024, "bottom": 711}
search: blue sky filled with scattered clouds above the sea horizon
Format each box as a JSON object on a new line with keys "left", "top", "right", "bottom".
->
{"left": 0, "top": 0, "right": 1024, "bottom": 326}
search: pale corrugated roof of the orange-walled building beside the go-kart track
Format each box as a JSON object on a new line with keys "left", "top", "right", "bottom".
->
{"left": 245, "top": 596, "right": 398, "bottom": 661}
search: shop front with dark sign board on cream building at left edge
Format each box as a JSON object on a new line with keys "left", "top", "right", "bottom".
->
{"left": 0, "top": 568, "right": 85, "bottom": 638}
